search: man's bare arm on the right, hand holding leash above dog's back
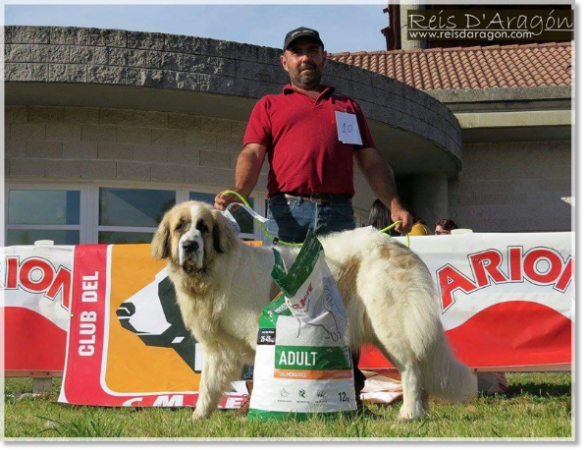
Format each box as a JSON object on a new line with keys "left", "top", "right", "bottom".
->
{"left": 354, "top": 148, "right": 413, "bottom": 233}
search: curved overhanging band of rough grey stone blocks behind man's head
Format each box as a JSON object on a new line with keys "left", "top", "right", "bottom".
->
{"left": 4, "top": 26, "right": 462, "bottom": 179}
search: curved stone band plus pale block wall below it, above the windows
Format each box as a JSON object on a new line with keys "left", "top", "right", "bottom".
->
{"left": 5, "top": 26, "right": 461, "bottom": 228}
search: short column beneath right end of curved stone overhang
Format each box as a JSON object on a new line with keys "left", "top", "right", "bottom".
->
{"left": 411, "top": 173, "right": 450, "bottom": 230}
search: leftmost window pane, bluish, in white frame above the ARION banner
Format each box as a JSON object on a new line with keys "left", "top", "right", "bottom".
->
{"left": 6, "top": 189, "right": 81, "bottom": 246}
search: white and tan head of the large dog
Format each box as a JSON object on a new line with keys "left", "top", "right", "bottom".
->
{"left": 151, "top": 201, "right": 238, "bottom": 274}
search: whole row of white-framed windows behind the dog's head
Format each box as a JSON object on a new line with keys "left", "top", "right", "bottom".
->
{"left": 4, "top": 182, "right": 266, "bottom": 246}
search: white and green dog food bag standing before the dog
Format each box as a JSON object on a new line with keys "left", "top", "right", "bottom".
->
{"left": 248, "top": 234, "right": 356, "bottom": 419}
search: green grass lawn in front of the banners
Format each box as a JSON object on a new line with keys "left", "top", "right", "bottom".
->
{"left": 4, "top": 372, "right": 574, "bottom": 440}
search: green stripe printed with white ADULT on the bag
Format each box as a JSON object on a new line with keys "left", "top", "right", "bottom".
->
{"left": 275, "top": 345, "right": 352, "bottom": 370}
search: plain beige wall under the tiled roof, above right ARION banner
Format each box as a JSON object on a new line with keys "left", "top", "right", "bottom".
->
{"left": 449, "top": 141, "right": 573, "bottom": 232}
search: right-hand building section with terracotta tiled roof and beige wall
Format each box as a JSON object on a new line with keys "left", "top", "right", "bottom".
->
{"left": 330, "top": 12, "right": 574, "bottom": 232}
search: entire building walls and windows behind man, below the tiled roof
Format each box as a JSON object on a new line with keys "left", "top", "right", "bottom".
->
{"left": 4, "top": 27, "right": 571, "bottom": 245}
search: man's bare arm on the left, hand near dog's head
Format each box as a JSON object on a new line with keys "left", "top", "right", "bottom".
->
{"left": 214, "top": 144, "right": 267, "bottom": 210}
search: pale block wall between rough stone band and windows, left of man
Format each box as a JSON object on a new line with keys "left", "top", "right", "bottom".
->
{"left": 5, "top": 106, "right": 258, "bottom": 187}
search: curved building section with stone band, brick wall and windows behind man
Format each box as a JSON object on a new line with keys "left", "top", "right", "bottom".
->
{"left": 4, "top": 27, "right": 461, "bottom": 244}
